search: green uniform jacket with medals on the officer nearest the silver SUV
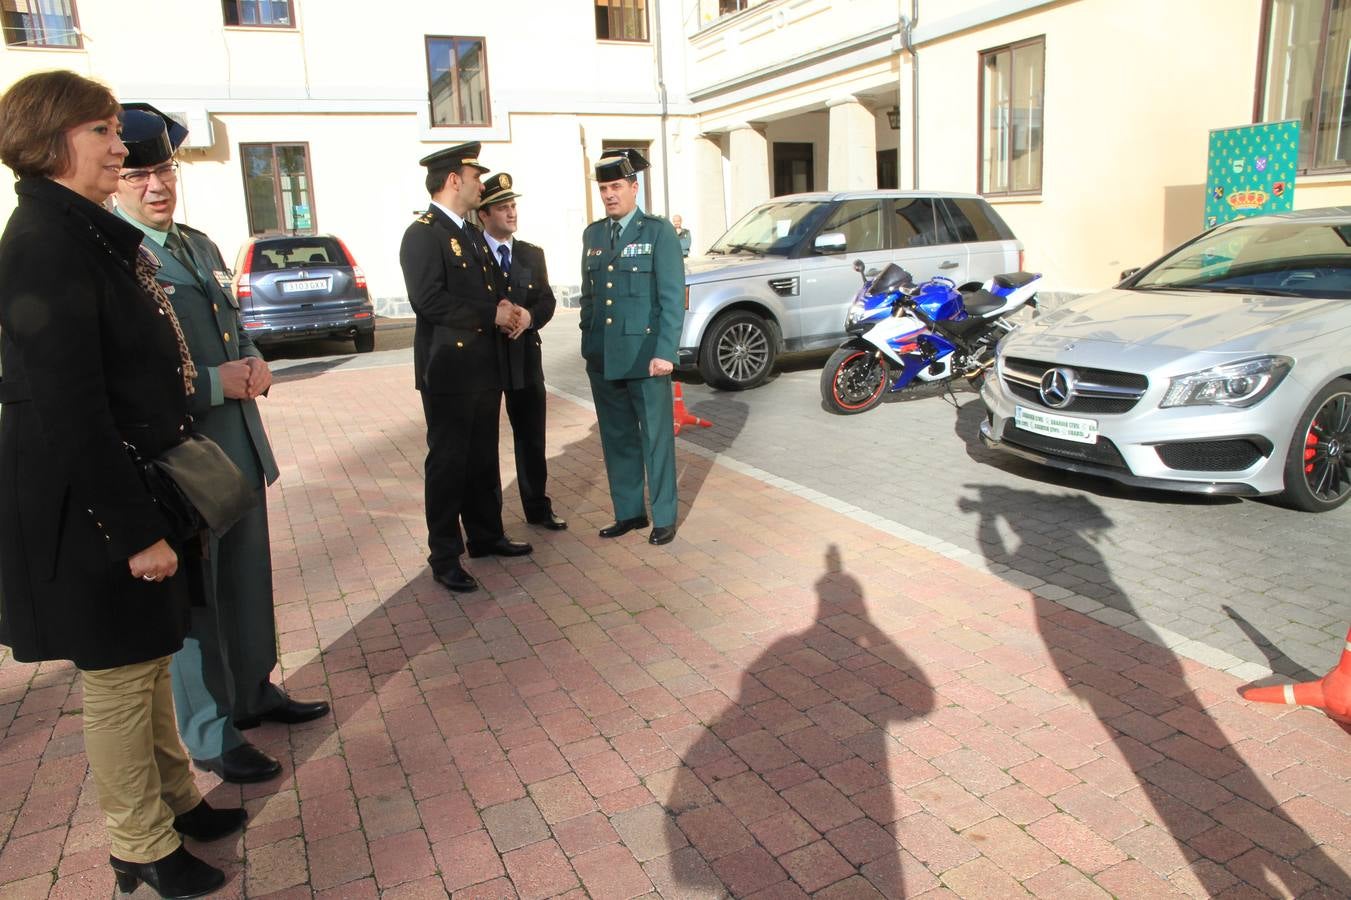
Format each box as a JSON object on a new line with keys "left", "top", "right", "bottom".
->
{"left": 581, "top": 209, "right": 685, "bottom": 381}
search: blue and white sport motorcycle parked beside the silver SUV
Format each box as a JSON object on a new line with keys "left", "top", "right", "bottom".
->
{"left": 821, "top": 261, "right": 1042, "bottom": 416}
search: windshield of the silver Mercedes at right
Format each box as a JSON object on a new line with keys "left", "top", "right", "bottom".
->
{"left": 1129, "top": 219, "right": 1351, "bottom": 299}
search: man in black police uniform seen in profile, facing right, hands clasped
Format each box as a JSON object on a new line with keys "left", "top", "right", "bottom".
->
{"left": 399, "top": 141, "right": 531, "bottom": 592}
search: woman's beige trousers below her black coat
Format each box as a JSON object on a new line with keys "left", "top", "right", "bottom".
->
{"left": 82, "top": 657, "right": 201, "bottom": 862}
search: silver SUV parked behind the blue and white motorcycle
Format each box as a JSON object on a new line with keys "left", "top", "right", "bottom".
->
{"left": 678, "top": 191, "right": 1023, "bottom": 391}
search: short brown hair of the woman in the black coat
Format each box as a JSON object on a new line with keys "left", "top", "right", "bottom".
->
{"left": 0, "top": 72, "right": 122, "bottom": 177}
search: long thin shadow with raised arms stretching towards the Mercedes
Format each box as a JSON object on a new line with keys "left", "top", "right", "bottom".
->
{"left": 958, "top": 485, "right": 1351, "bottom": 896}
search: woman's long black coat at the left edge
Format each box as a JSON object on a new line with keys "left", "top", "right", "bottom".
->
{"left": 0, "top": 178, "right": 192, "bottom": 669}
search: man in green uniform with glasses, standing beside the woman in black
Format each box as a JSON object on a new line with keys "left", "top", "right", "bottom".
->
{"left": 115, "top": 104, "right": 328, "bottom": 782}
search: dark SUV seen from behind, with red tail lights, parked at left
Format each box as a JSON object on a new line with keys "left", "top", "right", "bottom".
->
{"left": 232, "top": 234, "right": 376, "bottom": 353}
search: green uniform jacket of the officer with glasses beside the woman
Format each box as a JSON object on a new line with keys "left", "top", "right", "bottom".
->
{"left": 145, "top": 224, "right": 277, "bottom": 488}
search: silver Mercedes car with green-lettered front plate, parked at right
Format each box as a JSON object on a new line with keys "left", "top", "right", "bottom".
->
{"left": 981, "top": 207, "right": 1351, "bottom": 512}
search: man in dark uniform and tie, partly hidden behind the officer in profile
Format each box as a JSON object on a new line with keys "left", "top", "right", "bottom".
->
{"left": 478, "top": 172, "right": 567, "bottom": 531}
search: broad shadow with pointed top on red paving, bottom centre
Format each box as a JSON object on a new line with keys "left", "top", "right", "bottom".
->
{"left": 650, "top": 545, "right": 936, "bottom": 897}
